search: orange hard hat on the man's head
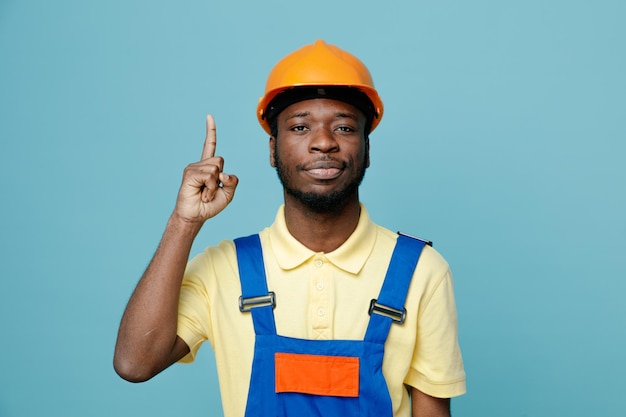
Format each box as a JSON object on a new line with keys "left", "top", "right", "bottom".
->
{"left": 257, "top": 39, "right": 383, "bottom": 135}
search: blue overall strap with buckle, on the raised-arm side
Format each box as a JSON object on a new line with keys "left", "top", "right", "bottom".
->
{"left": 234, "top": 234, "right": 276, "bottom": 335}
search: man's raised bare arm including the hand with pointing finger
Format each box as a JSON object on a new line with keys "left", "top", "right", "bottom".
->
{"left": 113, "top": 116, "right": 238, "bottom": 382}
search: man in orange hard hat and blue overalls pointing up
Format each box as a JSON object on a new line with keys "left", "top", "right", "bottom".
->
{"left": 114, "top": 41, "right": 465, "bottom": 416}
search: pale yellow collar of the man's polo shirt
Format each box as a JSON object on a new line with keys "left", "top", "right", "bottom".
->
{"left": 269, "top": 204, "right": 376, "bottom": 274}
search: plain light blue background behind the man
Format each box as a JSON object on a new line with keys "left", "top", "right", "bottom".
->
{"left": 0, "top": 0, "right": 626, "bottom": 417}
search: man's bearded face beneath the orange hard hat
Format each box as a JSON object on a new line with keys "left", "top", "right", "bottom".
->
{"left": 270, "top": 99, "right": 369, "bottom": 211}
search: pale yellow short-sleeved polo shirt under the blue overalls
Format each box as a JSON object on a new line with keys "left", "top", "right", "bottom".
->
{"left": 178, "top": 206, "right": 465, "bottom": 417}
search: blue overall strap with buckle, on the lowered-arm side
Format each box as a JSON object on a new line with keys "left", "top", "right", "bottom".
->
{"left": 365, "top": 234, "right": 427, "bottom": 343}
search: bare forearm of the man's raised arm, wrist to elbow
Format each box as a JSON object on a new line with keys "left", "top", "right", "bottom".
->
{"left": 114, "top": 215, "right": 200, "bottom": 381}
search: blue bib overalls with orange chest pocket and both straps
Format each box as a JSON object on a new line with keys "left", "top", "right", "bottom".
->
{"left": 235, "top": 235, "right": 429, "bottom": 417}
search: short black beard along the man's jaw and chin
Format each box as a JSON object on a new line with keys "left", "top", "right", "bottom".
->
{"left": 274, "top": 146, "right": 367, "bottom": 213}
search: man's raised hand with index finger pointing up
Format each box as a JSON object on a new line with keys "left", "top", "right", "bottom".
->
{"left": 174, "top": 115, "right": 239, "bottom": 224}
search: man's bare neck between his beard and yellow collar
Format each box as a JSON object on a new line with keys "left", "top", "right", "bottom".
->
{"left": 285, "top": 195, "right": 361, "bottom": 253}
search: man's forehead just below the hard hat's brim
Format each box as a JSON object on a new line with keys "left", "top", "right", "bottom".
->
{"left": 278, "top": 98, "right": 365, "bottom": 123}
